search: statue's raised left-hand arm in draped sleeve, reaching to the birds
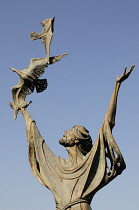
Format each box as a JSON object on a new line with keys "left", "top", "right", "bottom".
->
{"left": 20, "top": 108, "right": 55, "bottom": 190}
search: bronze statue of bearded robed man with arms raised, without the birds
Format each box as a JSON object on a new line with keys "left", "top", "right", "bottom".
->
{"left": 9, "top": 17, "right": 134, "bottom": 210}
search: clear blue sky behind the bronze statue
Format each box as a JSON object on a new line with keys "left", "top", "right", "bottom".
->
{"left": 0, "top": 0, "right": 139, "bottom": 210}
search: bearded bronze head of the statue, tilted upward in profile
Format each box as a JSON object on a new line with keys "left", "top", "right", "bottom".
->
{"left": 59, "top": 125, "right": 92, "bottom": 155}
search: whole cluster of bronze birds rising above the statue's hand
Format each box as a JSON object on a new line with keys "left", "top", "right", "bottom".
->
{"left": 9, "top": 18, "right": 67, "bottom": 119}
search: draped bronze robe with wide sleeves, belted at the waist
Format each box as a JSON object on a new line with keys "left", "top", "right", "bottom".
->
{"left": 27, "top": 115, "right": 126, "bottom": 210}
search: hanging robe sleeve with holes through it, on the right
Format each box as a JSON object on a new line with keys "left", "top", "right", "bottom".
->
{"left": 82, "top": 112, "right": 126, "bottom": 198}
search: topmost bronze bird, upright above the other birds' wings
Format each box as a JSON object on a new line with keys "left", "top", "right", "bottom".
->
{"left": 30, "top": 17, "right": 55, "bottom": 64}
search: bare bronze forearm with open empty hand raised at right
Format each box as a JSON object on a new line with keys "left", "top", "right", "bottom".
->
{"left": 107, "top": 66, "right": 135, "bottom": 129}
